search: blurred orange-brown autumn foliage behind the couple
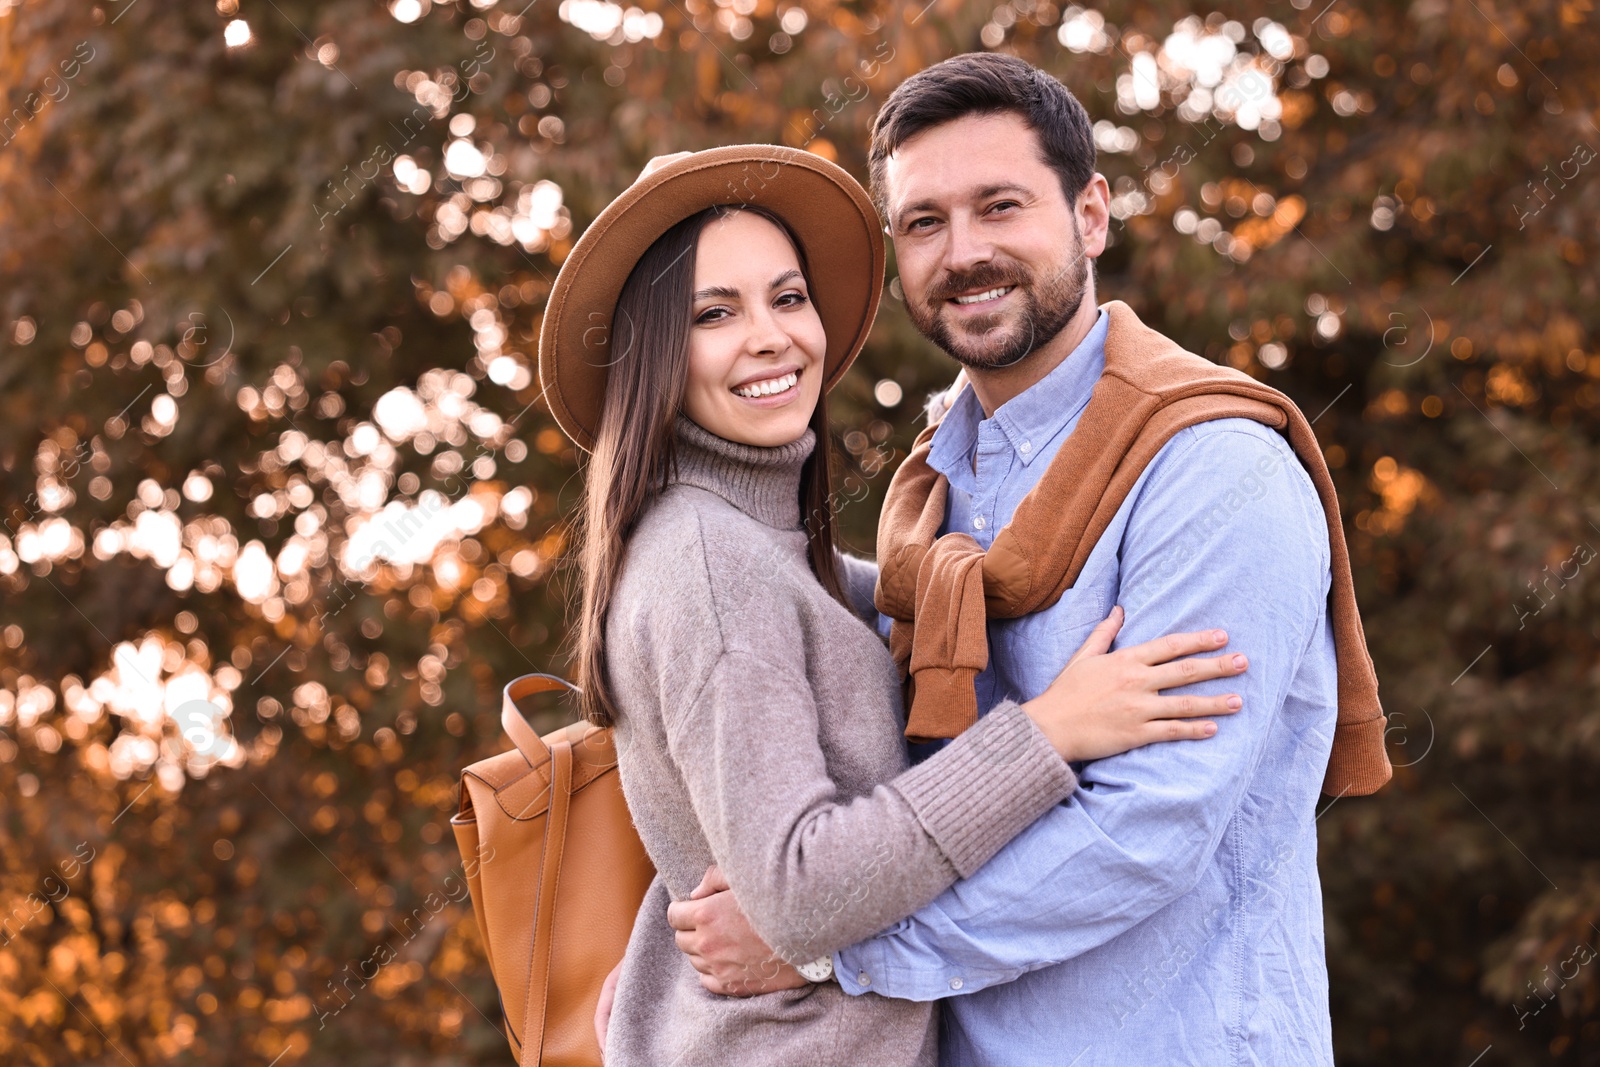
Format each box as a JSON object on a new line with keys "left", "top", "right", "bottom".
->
{"left": 0, "top": 0, "right": 1600, "bottom": 1064}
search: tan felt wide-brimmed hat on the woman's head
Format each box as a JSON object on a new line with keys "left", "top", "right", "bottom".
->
{"left": 539, "top": 144, "right": 883, "bottom": 451}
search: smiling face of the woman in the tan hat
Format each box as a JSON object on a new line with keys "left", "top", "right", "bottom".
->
{"left": 683, "top": 211, "right": 827, "bottom": 448}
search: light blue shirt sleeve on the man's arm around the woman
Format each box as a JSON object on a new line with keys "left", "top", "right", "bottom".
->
{"left": 835, "top": 422, "right": 1330, "bottom": 1000}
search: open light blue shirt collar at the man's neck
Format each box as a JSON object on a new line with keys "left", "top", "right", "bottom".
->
{"left": 928, "top": 309, "right": 1110, "bottom": 485}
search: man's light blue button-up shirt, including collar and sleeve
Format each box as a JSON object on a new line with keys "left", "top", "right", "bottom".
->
{"left": 834, "top": 310, "right": 1338, "bottom": 1067}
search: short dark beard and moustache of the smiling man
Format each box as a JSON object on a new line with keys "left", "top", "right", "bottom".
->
{"left": 906, "top": 230, "right": 1090, "bottom": 370}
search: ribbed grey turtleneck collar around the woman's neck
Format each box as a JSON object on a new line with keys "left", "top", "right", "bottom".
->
{"left": 667, "top": 411, "right": 816, "bottom": 530}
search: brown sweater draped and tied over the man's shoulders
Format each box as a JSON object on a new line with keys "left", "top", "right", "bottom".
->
{"left": 875, "top": 301, "right": 1392, "bottom": 797}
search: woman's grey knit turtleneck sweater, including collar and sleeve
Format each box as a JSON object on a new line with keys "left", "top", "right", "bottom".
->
{"left": 605, "top": 414, "right": 1077, "bottom": 1067}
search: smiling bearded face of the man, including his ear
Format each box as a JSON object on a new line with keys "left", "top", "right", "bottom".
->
{"left": 883, "top": 112, "right": 1106, "bottom": 370}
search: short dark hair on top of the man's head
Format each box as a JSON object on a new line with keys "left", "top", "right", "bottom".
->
{"left": 867, "top": 51, "right": 1094, "bottom": 221}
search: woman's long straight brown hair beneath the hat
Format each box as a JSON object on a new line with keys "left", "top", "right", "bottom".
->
{"left": 570, "top": 205, "right": 848, "bottom": 726}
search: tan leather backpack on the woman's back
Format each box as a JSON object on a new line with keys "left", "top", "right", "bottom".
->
{"left": 450, "top": 673, "right": 656, "bottom": 1067}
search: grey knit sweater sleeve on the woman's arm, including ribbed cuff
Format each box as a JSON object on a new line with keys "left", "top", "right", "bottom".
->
{"left": 666, "top": 521, "right": 1077, "bottom": 963}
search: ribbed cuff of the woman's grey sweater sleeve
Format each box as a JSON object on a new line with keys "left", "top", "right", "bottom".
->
{"left": 893, "top": 701, "right": 1078, "bottom": 878}
